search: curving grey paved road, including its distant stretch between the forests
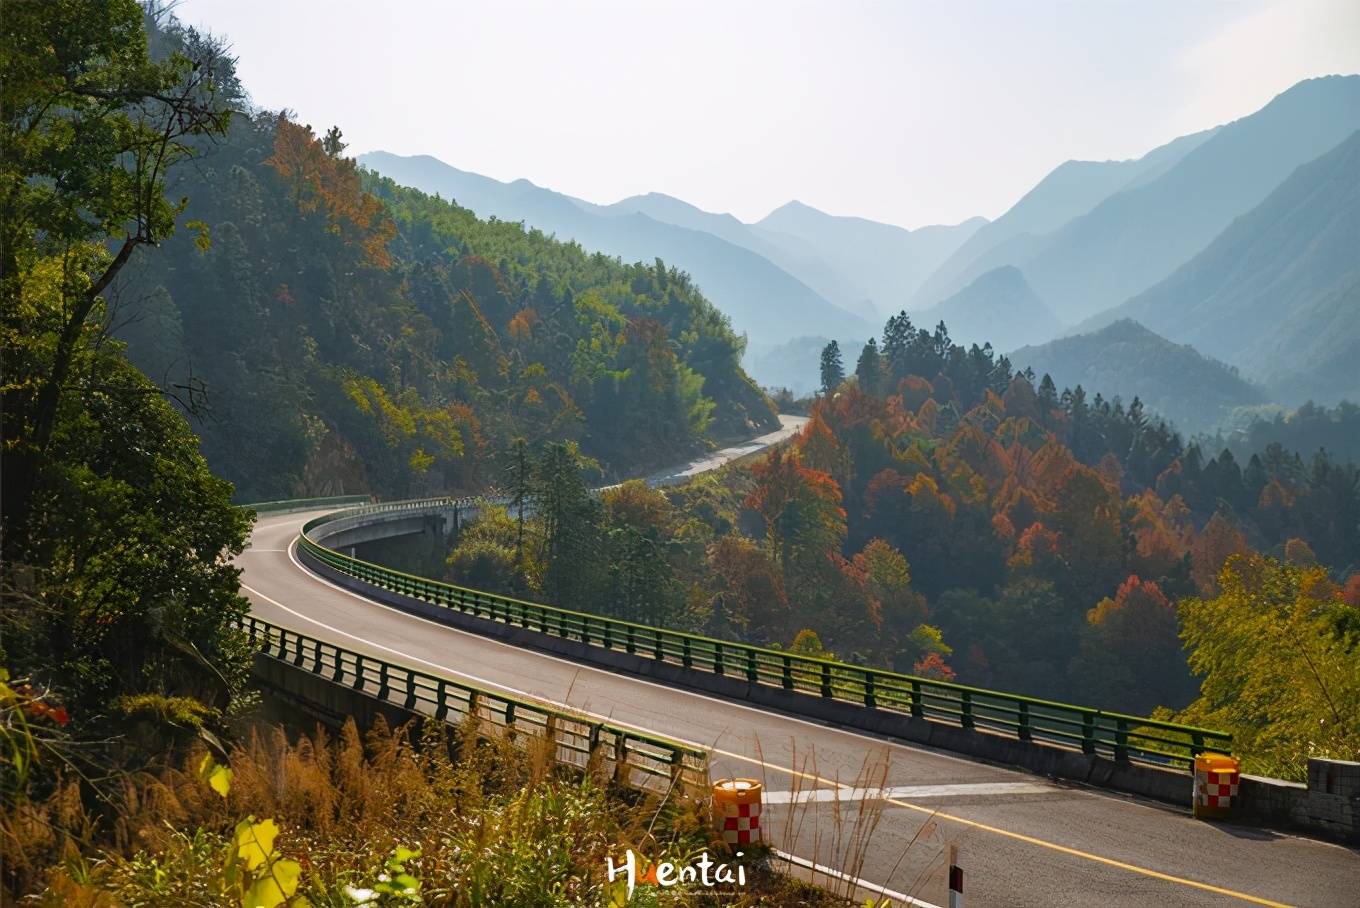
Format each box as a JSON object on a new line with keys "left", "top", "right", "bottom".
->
{"left": 238, "top": 417, "right": 1360, "bottom": 908}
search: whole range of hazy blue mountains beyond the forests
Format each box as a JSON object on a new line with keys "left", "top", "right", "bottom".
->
{"left": 360, "top": 76, "right": 1360, "bottom": 425}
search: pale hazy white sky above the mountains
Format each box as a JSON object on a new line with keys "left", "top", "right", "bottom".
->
{"left": 177, "top": 0, "right": 1360, "bottom": 227}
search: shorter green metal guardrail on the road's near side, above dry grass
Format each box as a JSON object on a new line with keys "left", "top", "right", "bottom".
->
{"left": 239, "top": 616, "right": 709, "bottom": 792}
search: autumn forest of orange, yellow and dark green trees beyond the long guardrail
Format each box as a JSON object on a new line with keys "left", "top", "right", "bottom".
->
{"left": 449, "top": 314, "right": 1360, "bottom": 775}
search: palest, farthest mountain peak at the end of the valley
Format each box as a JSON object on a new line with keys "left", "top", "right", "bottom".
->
{"left": 755, "top": 201, "right": 987, "bottom": 317}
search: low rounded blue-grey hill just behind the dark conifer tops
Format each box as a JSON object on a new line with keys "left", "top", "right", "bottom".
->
{"left": 1010, "top": 319, "right": 1265, "bottom": 432}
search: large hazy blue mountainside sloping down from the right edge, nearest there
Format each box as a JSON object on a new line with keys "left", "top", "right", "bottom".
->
{"left": 1092, "top": 132, "right": 1360, "bottom": 404}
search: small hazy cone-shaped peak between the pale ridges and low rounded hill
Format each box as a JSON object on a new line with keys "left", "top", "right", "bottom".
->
{"left": 911, "top": 265, "right": 1062, "bottom": 351}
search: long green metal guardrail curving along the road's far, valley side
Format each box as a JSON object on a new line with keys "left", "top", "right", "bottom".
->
{"left": 299, "top": 497, "right": 1232, "bottom": 767}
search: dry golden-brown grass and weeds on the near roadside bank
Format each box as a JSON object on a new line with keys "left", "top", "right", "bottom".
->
{"left": 0, "top": 723, "right": 845, "bottom": 907}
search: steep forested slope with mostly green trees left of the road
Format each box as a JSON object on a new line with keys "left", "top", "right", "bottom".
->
{"left": 114, "top": 114, "right": 775, "bottom": 499}
